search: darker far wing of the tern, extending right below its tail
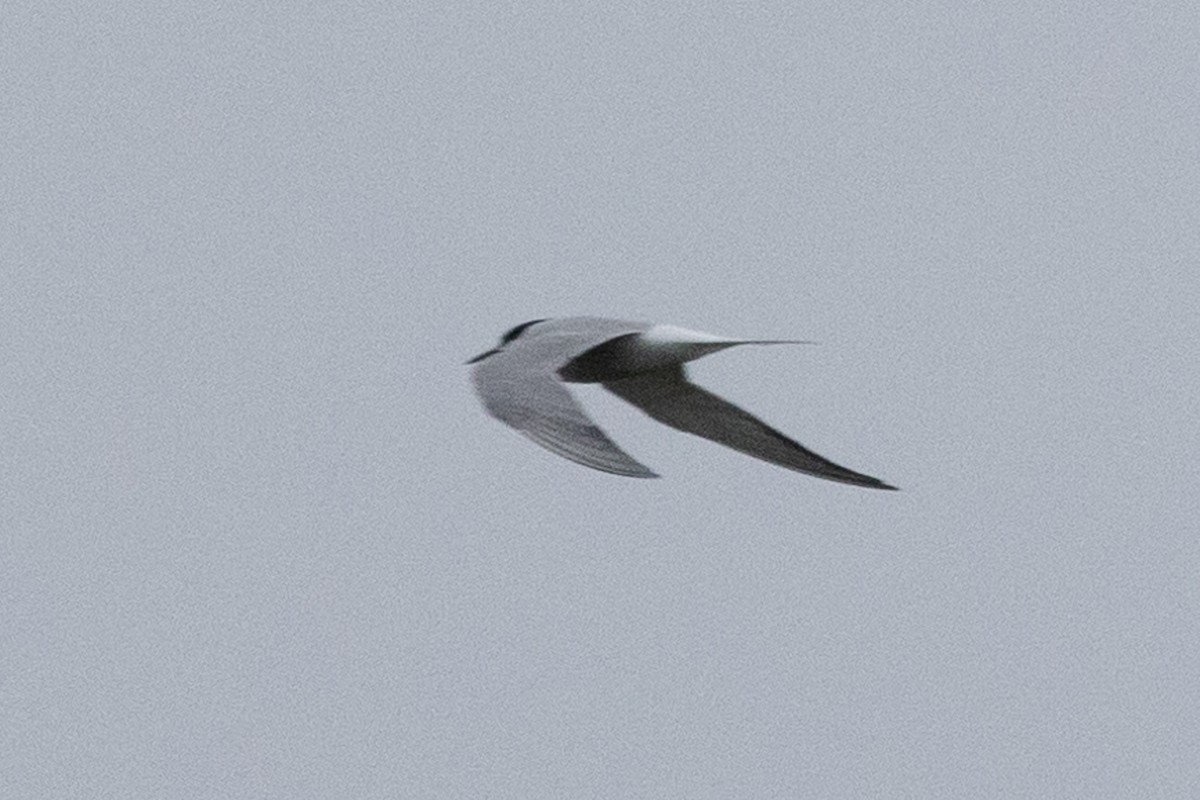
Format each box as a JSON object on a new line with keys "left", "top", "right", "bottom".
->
{"left": 604, "top": 366, "right": 895, "bottom": 489}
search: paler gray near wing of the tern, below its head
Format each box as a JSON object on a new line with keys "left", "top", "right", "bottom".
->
{"left": 472, "top": 350, "right": 658, "bottom": 477}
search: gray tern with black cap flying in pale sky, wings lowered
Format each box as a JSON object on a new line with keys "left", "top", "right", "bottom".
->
{"left": 467, "top": 317, "right": 895, "bottom": 489}
